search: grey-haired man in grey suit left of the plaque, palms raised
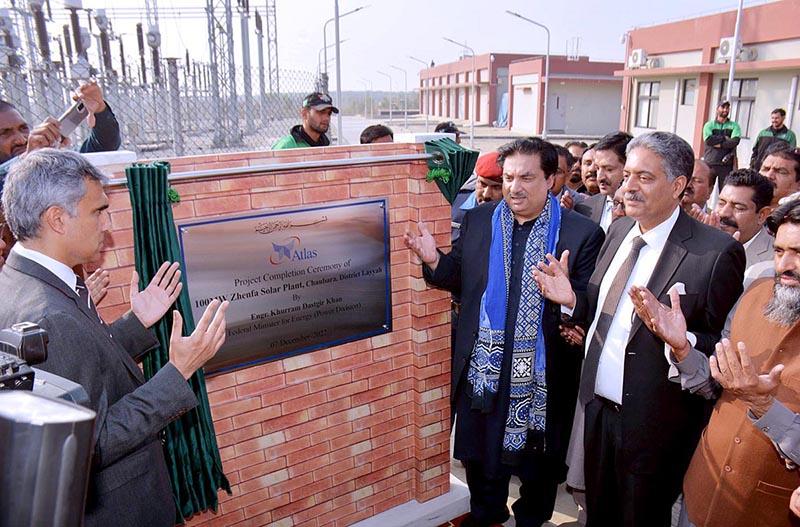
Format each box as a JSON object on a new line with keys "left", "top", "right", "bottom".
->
{"left": 0, "top": 148, "right": 227, "bottom": 527}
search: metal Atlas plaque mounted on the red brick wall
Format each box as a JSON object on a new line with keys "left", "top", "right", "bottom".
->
{"left": 178, "top": 198, "right": 392, "bottom": 374}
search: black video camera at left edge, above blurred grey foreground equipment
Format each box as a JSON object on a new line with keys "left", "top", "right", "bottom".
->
{"left": 0, "top": 322, "right": 89, "bottom": 405}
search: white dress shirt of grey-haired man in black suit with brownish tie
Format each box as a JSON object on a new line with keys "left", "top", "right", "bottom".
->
{"left": 586, "top": 207, "right": 680, "bottom": 404}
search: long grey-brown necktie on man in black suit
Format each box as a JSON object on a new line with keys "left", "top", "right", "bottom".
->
{"left": 578, "top": 236, "right": 647, "bottom": 405}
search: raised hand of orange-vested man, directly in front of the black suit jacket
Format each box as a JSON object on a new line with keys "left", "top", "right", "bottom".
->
{"left": 628, "top": 285, "right": 691, "bottom": 361}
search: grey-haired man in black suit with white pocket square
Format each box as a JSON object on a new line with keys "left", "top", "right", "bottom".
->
{"left": 545, "top": 132, "right": 745, "bottom": 527}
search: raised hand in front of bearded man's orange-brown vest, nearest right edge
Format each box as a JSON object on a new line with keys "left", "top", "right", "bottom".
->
{"left": 709, "top": 339, "right": 783, "bottom": 417}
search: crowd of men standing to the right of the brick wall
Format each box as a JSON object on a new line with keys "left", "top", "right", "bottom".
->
{"left": 404, "top": 101, "right": 800, "bottom": 527}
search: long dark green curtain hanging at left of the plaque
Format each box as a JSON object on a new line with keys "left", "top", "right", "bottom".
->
{"left": 125, "top": 162, "right": 231, "bottom": 523}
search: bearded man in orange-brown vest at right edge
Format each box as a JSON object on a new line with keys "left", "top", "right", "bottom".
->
{"left": 632, "top": 201, "right": 800, "bottom": 527}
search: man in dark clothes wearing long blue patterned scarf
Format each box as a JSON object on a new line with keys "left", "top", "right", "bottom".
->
{"left": 405, "top": 138, "right": 603, "bottom": 527}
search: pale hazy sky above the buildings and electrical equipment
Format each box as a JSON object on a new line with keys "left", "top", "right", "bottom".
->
{"left": 29, "top": 0, "right": 770, "bottom": 91}
